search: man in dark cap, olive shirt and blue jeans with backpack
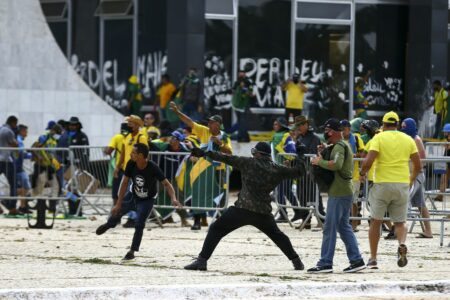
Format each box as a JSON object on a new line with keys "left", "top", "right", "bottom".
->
{"left": 308, "top": 118, "right": 366, "bottom": 273}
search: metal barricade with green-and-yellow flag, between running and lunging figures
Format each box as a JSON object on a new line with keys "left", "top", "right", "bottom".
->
{"left": 150, "top": 151, "right": 230, "bottom": 218}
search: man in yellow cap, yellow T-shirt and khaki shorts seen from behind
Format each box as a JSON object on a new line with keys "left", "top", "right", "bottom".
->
{"left": 360, "top": 111, "right": 421, "bottom": 269}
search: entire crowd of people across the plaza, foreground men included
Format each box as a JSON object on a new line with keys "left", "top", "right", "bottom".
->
{"left": 0, "top": 69, "right": 450, "bottom": 273}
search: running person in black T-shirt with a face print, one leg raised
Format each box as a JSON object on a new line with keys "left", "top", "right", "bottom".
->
{"left": 95, "top": 143, "right": 181, "bottom": 260}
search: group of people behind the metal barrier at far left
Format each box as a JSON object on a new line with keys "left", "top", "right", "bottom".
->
{"left": 0, "top": 116, "right": 89, "bottom": 216}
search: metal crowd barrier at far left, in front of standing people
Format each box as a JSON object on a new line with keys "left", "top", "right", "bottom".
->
{"left": 0, "top": 147, "right": 73, "bottom": 228}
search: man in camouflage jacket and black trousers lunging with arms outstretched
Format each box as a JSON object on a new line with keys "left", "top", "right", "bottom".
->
{"left": 184, "top": 142, "right": 306, "bottom": 271}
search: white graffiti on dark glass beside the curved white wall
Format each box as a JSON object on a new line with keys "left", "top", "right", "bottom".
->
{"left": 71, "top": 51, "right": 167, "bottom": 111}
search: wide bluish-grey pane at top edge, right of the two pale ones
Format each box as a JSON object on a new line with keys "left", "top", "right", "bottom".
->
{"left": 297, "top": 2, "right": 351, "bottom": 20}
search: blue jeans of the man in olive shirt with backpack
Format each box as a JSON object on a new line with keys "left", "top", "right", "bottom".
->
{"left": 317, "top": 195, "right": 362, "bottom": 266}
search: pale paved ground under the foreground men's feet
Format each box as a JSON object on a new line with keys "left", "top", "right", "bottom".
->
{"left": 0, "top": 199, "right": 450, "bottom": 298}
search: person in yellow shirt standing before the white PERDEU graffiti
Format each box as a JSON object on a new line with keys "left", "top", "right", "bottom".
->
{"left": 283, "top": 73, "right": 308, "bottom": 122}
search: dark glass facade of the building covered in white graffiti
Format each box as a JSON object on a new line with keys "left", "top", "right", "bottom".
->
{"left": 44, "top": 0, "right": 412, "bottom": 130}
